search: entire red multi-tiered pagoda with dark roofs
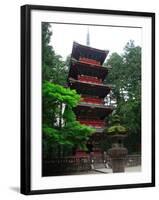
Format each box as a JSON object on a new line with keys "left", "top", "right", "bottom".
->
{"left": 68, "top": 42, "right": 113, "bottom": 159}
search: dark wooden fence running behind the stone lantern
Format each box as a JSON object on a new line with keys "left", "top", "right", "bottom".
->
{"left": 42, "top": 154, "right": 141, "bottom": 176}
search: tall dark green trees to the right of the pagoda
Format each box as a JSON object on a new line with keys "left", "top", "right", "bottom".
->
{"left": 106, "top": 41, "right": 141, "bottom": 152}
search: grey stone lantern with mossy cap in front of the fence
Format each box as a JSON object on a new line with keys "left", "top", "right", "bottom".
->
{"left": 107, "top": 115, "right": 128, "bottom": 173}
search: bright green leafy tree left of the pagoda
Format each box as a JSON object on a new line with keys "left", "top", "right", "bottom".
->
{"left": 42, "top": 82, "right": 94, "bottom": 159}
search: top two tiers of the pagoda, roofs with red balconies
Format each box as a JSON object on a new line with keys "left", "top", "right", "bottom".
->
{"left": 68, "top": 42, "right": 109, "bottom": 84}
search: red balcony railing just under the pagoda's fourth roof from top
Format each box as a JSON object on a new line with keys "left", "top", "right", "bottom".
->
{"left": 78, "top": 119, "right": 106, "bottom": 128}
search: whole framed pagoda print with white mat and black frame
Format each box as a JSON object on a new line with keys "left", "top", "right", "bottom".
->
{"left": 21, "top": 5, "right": 155, "bottom": 194}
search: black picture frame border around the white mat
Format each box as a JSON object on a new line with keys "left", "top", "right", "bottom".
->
{"left": 21, "top": 5, "right": 155, "bottom": 195}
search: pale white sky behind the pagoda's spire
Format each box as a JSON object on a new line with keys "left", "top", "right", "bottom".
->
{"left": 50, "top": 23, "right": 142, "bottom": 60}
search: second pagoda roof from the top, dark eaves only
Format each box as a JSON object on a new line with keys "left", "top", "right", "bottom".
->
{"left": 68, "top": 60, "right": 108, "bottom": 81}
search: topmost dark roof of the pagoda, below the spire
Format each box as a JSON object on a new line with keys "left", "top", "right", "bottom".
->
{"left": 71, "top": 42, "right": 109, "bottom": 65}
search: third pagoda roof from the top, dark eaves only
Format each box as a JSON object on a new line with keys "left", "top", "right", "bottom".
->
{"left": 69, "top": 79, "right": 111, "bottom": 98}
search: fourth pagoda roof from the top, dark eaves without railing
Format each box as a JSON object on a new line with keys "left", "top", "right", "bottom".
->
{"left": 74, "top": 103, "right": 113, "bottom": 120}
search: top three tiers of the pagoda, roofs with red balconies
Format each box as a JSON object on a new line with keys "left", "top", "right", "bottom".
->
{"left": 68, "top": 42, "right": 111, "bottom": 101}
